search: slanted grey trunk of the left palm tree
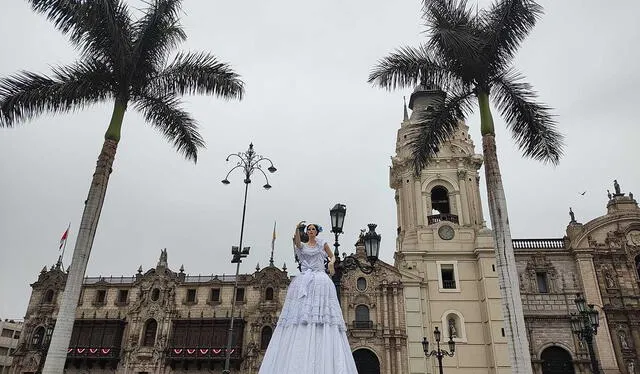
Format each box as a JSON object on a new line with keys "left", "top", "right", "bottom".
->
{"left": 42, "top": 102, "right": 126, "bottom": 374}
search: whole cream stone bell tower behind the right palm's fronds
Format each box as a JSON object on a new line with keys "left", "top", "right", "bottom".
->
{"left": 389, "top": 85, "right": 509, "bottom": 374}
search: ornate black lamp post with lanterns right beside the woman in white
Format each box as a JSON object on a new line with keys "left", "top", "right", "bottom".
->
{"left": 329, "top": 204, "right": 382, "bottom": 302}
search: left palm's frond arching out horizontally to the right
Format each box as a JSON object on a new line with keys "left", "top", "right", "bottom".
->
{"left": 149, "top": 52, "right": 244, "bottom": 99}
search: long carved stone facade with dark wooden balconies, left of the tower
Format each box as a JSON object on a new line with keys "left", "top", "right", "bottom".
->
{"left": 11, "top": 240, "right": 407, "bottom": 374}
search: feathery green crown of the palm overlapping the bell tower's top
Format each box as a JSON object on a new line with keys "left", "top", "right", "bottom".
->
{"left": 369, "top": 0, "right": 563, "bottom": 171}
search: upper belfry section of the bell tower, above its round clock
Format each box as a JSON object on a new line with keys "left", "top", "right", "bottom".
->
{"left": 390, "top": 86, "right": 484, "bottom": 251}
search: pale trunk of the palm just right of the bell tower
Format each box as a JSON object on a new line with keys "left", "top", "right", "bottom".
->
{"left": 478, "top": 92, "right": 532, "bottom": 374}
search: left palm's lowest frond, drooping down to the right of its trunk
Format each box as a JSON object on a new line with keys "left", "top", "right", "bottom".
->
{"left": 132, "top": 95, "right": 204, "bottom": 162}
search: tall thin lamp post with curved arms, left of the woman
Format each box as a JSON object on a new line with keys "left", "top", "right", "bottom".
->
{"left": 222, "top": 143, "right": 277, "bottom": 374}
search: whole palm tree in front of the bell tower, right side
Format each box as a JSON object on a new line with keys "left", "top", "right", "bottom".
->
{"left": 369, "top": 0, "right": 563, "bottom": 374}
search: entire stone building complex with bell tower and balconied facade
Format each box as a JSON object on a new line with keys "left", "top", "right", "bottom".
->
{"left": 10, "top": 86, "right": 640, "bottom": 374}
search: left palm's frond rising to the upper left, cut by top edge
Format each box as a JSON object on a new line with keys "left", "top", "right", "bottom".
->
{"left": 29, "top": 0, "right": 132, "bottom": 68}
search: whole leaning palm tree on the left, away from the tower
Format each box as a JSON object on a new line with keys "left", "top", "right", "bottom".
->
{"left": 0, "top": 0, "right": 244, "bottom": 373}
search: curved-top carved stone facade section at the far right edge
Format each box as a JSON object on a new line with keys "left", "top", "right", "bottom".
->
{"left": 567, "top": 188, "right": 640, "bottom": 374}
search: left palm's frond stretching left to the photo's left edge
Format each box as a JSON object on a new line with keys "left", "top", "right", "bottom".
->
{"left": 0, "top": 60, "right": 113, "bottom": 127}
